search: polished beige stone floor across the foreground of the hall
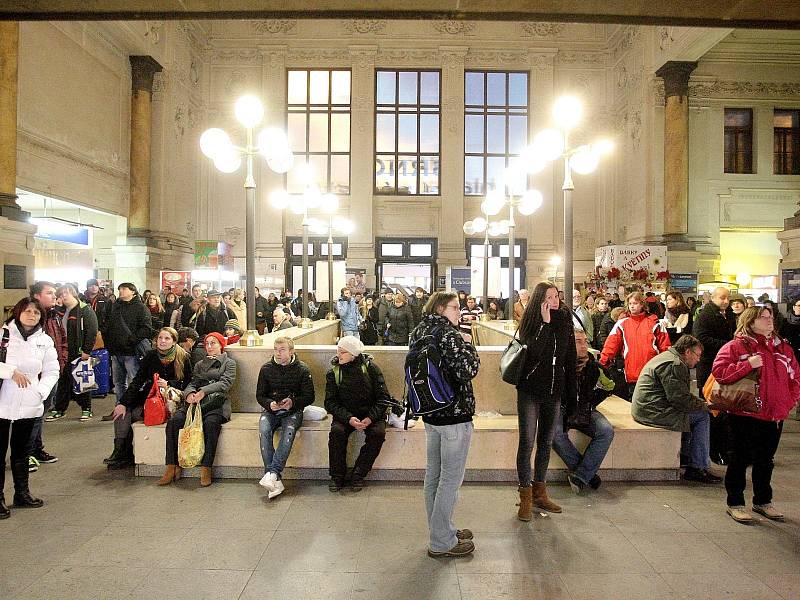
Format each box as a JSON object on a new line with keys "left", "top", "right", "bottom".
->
{"left": 0, "top": 399, "right": 800, "bottom": 600}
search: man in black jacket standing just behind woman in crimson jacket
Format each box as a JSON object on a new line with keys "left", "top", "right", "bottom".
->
{"left": 684, "top": 287, "right": 736, "bottom": 465}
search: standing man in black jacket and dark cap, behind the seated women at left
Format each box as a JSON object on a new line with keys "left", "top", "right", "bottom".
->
{"left": 102, "top": 282, "right": 155, "bottom": 404}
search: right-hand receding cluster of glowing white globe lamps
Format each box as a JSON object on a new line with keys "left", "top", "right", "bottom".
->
{"left": 464, "top": 96, "right": 614, "bottom": 236}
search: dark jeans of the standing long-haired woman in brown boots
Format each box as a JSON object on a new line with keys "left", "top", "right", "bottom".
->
{"left": 517, "top": 390, "right": 561, "bottom": 487}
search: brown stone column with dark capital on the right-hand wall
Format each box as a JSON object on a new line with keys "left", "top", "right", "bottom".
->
{"left": 656, "top": 61, "right": 697, "bottom": 247}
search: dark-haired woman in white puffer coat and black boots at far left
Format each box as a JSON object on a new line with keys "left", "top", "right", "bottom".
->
{"left": 0, "top": 298, "right": 58, "bottom": 519}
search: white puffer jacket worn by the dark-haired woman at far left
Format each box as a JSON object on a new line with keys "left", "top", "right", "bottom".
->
{"left": 0, "top": 321, "right": 59, "bottom": 421}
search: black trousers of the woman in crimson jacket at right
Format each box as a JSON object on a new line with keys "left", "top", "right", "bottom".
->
{"left": 725, "top": 414, "right": 783, "bottom": 506}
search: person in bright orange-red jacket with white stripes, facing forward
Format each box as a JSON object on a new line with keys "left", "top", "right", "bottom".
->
{"left": 600, "top": 292, "right": 670, "bottom": 400}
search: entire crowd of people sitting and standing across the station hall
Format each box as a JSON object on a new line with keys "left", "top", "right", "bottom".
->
{"left": 0, "top": 279, "right": 800, "bottom": 557}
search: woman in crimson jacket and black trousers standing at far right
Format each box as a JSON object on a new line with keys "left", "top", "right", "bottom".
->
{"left": 711, "top": 307, "right": 800, "bottom": 523}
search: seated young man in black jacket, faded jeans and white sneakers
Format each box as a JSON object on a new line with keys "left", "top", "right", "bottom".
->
{"left": 256, "top": 337, "right": 314, "bottom": 498}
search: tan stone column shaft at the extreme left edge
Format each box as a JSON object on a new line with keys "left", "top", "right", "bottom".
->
{"left": 0, "top": 21, "right": 27, "bottom": 221}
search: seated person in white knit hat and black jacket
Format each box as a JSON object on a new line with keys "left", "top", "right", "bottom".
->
{"left": 325, "top": 335, "right": 390, "bottom": 492}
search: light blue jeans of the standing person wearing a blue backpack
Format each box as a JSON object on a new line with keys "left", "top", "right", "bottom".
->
{"left": 424, "top": 422, "right": 473, "bottom": 552}
